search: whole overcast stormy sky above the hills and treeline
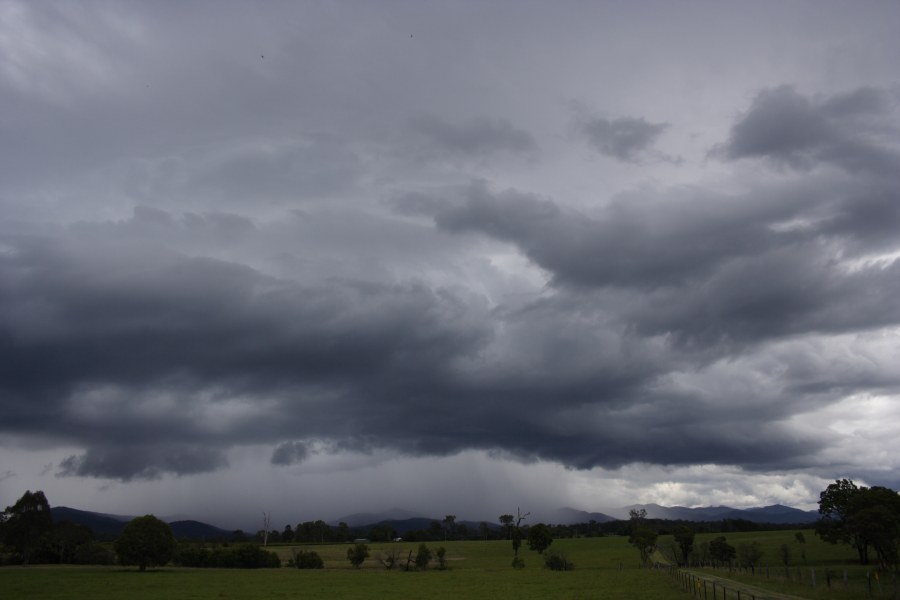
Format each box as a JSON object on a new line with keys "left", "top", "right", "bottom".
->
{"left": 0, "top": 0, "right": 900, "bottom": 528}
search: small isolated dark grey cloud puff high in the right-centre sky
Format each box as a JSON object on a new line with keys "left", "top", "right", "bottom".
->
{"left": 576, "top": 117, "right": 669, "bottom": 163}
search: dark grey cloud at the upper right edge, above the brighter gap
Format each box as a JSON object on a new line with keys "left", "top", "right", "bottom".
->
{"left": 714, "top": 85, "right": 900, "bottom": 176}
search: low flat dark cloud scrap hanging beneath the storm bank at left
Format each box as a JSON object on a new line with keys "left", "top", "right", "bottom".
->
{"left": 57, "top": 443, "right": 228, "bottom": 481}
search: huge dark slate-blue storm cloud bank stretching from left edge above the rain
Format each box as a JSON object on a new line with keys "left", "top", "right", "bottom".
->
{"left": 0, "top": 211, "right": 840, "bottom": 480}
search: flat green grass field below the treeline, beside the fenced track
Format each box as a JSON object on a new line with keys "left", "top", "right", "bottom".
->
{"left": 0, "top": 532, "right": 888, "bottom": 600}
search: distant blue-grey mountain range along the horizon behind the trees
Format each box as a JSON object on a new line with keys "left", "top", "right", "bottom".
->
{"left": 50, "top": 504, "right": 819, "bottom": 540}
